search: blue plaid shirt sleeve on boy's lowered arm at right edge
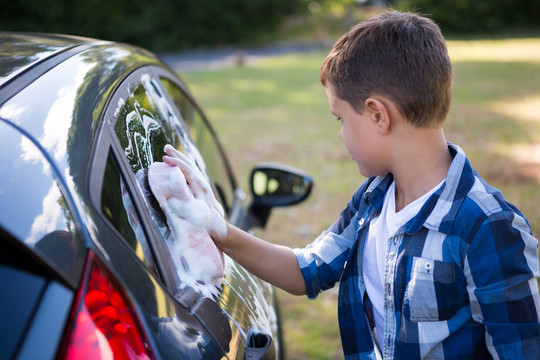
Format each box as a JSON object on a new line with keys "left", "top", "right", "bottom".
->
{"left": 464, "top": 210, "right": 540, "bottom": 359}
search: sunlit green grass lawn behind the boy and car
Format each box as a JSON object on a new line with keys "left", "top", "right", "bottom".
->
{"left": 182, "top": 39, "right": 540, "bottom": 359}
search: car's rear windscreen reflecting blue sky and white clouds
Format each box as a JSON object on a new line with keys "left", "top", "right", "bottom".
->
{"left": 0, "top": 120, "right": 84, "bottom": 281}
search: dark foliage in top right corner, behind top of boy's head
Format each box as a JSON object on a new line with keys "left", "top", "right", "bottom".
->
{"left": 396, "top": 0, "right": 540, "bottom": 33}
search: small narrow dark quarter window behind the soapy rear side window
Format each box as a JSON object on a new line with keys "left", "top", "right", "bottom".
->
{"left": 101, "top": 153, "right": 155, "bottom": 272}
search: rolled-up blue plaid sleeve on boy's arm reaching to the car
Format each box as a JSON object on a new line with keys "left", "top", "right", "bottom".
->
{"left": 293, "top": 190, "right": 360, "bottom": 299}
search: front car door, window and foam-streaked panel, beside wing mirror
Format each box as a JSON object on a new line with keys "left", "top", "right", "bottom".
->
{"left": 157, "top": 71, "right": 284, "bottom": 358}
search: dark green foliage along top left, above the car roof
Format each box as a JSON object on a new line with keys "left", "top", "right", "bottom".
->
{"left": 0, "top": 0, "right": 300, "bottom": 51}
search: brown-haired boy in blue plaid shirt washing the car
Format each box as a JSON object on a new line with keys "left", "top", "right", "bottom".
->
{"left": 179, "top": 12, "right": 540, "bottom": 359}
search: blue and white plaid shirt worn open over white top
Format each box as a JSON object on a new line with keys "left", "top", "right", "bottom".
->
{"left": 295, "top": 144, "right": 540, "bottom": 360}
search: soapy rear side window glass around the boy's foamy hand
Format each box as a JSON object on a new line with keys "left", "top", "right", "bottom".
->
{"left": 113, "top": 76, "right": 224, "bottom": 296}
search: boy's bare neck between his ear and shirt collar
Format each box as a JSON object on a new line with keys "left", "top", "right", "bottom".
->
{"left": 391, "top": 128, "right": 452, "bottom": 211}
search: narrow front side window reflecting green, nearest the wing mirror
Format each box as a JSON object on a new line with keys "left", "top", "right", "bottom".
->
{"left": 161, "top": 78, "right": 230, "bottom": 210}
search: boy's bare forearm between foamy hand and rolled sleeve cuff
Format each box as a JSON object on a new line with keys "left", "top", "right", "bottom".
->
{"left": 216, "top": 224, "right": 306, "bottom": 295}
